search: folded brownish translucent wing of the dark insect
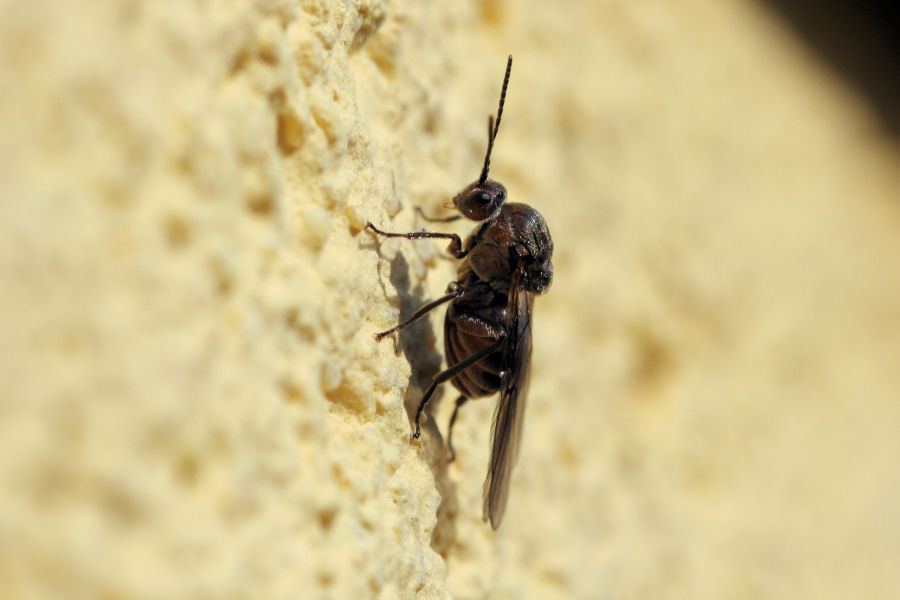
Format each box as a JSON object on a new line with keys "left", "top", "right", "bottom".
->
{"left": 483, "top": 271, "right": 534, "bottom": 529}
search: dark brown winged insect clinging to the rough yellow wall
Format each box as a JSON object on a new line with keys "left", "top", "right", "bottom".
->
{"left": 367, "top": 56, "right": 553, "bottom": 529}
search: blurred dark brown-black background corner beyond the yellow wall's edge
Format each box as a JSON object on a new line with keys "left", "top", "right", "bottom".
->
{"left": 762, "top": 0, "right": 900, "bottom": 139}
